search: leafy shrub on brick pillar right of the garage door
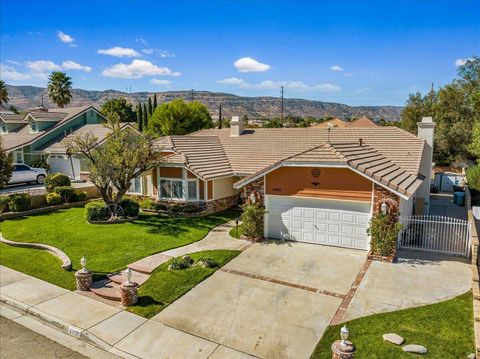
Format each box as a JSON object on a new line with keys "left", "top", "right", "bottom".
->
{"left": 367, "top": 213, "right": 402, "bottom": 256}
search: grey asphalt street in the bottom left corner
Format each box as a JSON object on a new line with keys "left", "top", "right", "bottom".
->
{"left": 0, "top": 317, "right": 86, "bottom": 359}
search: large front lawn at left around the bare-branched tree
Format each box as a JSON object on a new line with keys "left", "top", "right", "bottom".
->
{"left": 0, "top": 207, "right": 237, "bottom": 285}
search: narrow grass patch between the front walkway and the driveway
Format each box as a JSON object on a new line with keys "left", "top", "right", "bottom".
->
{"left": 128, "top": 250, "right": 241, "bottom": 318}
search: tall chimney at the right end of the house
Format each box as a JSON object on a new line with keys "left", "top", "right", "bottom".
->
{"left": 416, "top": 117, "right": 436, "bottom": 215}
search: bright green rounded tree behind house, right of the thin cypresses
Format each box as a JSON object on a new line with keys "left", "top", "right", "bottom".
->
{"left": 149, "top": 99, "right": 213, "bottom": 136}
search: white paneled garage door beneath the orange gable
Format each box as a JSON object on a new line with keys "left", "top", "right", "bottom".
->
{"left": 265, "top": 196, "right": 371, "bottom": 249}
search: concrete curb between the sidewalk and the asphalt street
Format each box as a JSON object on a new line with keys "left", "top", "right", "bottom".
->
{"left": 0, "top": 294, "right": 119, "bottom": 355}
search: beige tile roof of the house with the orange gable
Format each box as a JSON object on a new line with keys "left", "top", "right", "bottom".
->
{"left": 156, "top": 127, "right": 424, "bottom": 194}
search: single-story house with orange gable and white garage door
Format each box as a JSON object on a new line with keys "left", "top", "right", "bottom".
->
{"left": 136, "top": 118, "right": 435, "bottom": 249}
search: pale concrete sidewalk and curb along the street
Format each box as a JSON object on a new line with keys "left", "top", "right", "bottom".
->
{"left": 0, "top": 266, "right": 252, "bottom": 359}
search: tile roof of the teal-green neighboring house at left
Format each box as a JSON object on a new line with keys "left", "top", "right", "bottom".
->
{"left": 1, "top": 106, "right": 102, "bottom": 150}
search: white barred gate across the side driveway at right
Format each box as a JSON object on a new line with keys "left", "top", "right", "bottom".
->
{"left": 398, "top": 215, "right": 471, "bottom": 257}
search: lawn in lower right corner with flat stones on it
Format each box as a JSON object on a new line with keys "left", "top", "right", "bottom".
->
{"left": 312, "top": 292, "right": 475, "bottom": 359}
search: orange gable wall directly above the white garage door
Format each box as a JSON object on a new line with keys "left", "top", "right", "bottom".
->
{"left": 265, "top": 167, "right": 372, "bottom": 202}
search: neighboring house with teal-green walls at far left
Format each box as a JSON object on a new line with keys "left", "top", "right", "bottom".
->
{"left": 0, "top": 106, "right": 105, "bottom": 179}
